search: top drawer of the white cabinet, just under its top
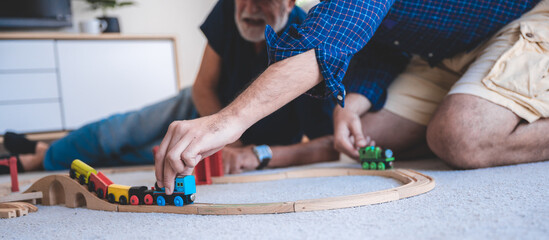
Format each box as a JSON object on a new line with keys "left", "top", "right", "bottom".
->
{"left": 0, "top": 40, "right": 55, "bottom": 71}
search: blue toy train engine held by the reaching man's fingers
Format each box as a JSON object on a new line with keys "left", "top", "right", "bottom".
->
{"left": 153, "top": 175, "right": 196, "bottom": 207}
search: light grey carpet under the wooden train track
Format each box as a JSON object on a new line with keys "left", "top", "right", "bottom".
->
{"left": 0, "top": 159, "right": 549, "bottom": 239}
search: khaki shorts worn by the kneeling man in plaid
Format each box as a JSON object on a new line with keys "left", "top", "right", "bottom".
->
{"left": 385, "top": 0, "right": 549, "bottom": 125}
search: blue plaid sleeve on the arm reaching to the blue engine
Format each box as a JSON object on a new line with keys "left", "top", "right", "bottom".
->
{"left": 265, "top": 0, "right": 394, "bottom": 106}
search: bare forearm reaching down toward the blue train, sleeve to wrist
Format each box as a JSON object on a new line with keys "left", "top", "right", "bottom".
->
{"left": 220, "top": 50, "right": 322, "bottom": 129}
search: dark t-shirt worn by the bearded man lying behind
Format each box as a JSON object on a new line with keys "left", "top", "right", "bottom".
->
{"left": 200, "top": 0, "right": 334, "bottom": 145}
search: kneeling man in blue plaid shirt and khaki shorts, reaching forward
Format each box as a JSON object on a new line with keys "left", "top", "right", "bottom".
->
{"left": 155, "top": 0, "right": 549, "bottom": 194}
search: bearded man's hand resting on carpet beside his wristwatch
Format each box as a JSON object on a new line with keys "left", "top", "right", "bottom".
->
{"left": 223, "top": 145, "right": 259, "bottom": 174}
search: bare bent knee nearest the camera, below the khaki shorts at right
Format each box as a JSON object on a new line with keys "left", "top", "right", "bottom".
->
{"left": 427, "top": 94, "right": 549, "bottom": 169}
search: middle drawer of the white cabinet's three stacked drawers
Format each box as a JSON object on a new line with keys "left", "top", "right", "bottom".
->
{"left": 0, "top": 72, "right": 59, "bottom": 103}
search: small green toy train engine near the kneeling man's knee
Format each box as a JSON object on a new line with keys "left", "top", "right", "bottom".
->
{"left": 358, "top": 146, "right": 395, "bottom": 170}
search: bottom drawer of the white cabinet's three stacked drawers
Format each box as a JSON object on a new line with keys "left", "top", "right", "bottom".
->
{"left": 0, "top": 102, "right": 63, "bottom": 133}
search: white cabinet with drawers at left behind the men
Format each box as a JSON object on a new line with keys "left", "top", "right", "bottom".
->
{"left": 0, "top": 34, "right": 178, "bottom": 135}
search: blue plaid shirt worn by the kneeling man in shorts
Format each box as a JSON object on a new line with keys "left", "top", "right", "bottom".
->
{"left": 265, "top": 0, "right": 540, "bottom": 110}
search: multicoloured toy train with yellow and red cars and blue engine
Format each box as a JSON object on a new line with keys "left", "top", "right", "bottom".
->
{"left": 69, "top": 159, "right": 196, "bottom": 206}
